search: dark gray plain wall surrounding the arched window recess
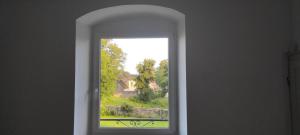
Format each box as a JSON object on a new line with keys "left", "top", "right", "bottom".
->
{"left": 0, "top": 0, "right": 291, "bottom": 135}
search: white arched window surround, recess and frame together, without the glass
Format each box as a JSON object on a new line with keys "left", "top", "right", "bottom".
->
{"left": 74, "top": 5, "right": 187, "bottom": 135}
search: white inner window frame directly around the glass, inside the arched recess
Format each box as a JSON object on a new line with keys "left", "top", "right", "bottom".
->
{"left": 91, "top": 15, "right": 178, "bottom": 135}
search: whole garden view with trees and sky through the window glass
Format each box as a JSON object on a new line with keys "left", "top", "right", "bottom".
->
{"left": 99, "top": 38, "right": 169, "bottom": 128}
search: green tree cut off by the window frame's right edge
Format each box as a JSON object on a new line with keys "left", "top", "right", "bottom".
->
{"left": 155, "top": 60, "right": 169, "bottom": 97}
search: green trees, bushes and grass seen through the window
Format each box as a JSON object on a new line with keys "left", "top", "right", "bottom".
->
{"left": 99, "top": 39, "right": 169, "bottom": 125}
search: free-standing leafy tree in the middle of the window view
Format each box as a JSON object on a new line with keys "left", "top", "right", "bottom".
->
{"left": 135, "top": 59, "right": 155, "bottom": 102}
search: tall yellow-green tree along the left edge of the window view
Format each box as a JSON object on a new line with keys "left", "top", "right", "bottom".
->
{"left": 100, "top": 39, "right": 125, "bottom": 96}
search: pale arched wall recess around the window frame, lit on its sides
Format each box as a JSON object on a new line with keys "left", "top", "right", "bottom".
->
{"left": 74, "top": 5, "right": 187, "bottom": 135}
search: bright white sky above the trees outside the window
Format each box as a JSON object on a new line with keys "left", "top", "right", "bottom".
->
{"left": 112, "top": 38, "right": 168, "bottom": 74}
